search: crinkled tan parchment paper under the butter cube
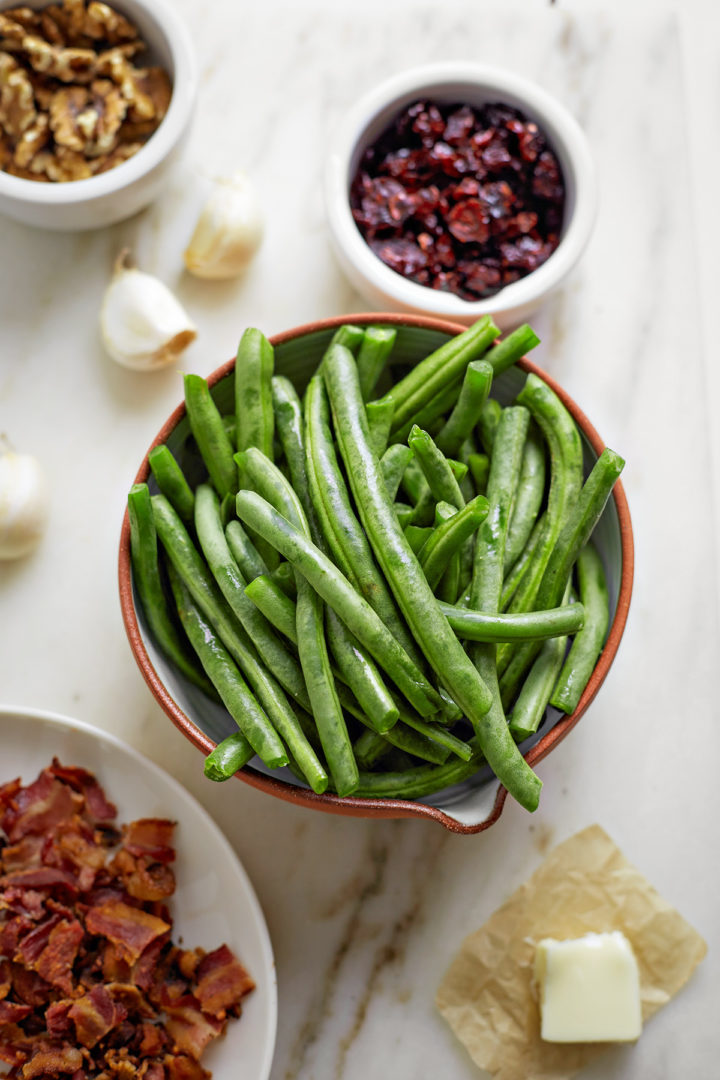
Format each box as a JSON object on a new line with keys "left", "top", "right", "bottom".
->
{"left": 436, "top": 825, "right": 707, "bottom": 1080}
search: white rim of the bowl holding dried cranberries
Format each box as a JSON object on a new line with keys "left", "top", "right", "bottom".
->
{"left": 324, "top": 60, "right": 597, "bottom": 320}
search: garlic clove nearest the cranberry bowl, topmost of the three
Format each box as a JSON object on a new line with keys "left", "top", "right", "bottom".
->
{"left": 185, "top": 173, "right": 263, "bottom": 280}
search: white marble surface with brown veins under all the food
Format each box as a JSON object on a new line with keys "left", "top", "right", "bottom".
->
{"left": 0, "top": 0, "right": 720, "bottom": 1080}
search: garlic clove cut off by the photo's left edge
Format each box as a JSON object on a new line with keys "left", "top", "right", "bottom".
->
{"left": 0, "top": 448, "right": 47, "bottom": 558}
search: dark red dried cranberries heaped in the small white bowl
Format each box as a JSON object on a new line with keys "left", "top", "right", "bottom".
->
{"left": 350, "top": 102, "right": 565, "bottom": 300}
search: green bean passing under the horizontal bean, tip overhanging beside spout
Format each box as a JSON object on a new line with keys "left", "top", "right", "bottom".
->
{"left": 470, "top": 407, "right": 542, "bottom": 809}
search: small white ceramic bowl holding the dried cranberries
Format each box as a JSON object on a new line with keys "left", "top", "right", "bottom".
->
{"left": 325, "top": 62, "right": 597, "bottom": 329}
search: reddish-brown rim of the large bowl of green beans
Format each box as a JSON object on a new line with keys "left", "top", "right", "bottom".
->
{"left": 118, "top": 312, "right": 635, "bottom": 834}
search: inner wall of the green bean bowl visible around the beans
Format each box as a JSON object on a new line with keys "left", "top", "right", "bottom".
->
{"left": 134, "top": 326, "right": 622, "bottom": 825}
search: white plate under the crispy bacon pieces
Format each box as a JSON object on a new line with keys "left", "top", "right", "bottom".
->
{"left": 0, "top": 706, "right": 277, "bottom": 1080}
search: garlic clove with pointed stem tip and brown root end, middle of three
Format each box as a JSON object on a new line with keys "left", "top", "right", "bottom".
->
{"left": 100, "top": 252, "right": 198, "bottom": 372}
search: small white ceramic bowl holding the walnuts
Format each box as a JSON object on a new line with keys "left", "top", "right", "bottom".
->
{"left": 0, "top": 0, "right": 198, "bottom": 230}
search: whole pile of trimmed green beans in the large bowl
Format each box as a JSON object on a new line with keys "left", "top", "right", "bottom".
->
{"left": 128, "top": 316, "right": 624, "bottom": 810}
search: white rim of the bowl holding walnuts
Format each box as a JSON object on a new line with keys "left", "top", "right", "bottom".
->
{"left": 0, "top": 0, "right": 198, "bottom": 207}
